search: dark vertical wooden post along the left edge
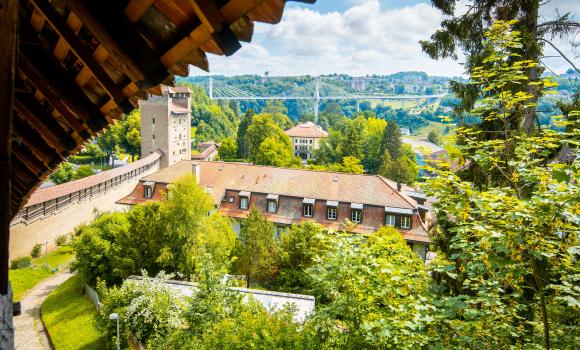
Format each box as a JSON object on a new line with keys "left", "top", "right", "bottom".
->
{"left": 0, "top": 0, "right": 19, "bottom": 296}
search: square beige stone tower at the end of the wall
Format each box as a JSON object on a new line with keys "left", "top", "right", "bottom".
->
{"left": 139, "top": 85, "right": 191, "bottom": 168}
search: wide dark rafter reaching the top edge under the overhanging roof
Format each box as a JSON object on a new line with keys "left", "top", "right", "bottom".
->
{"left": 65, "top": 0, "right": 169, "bottom": 88}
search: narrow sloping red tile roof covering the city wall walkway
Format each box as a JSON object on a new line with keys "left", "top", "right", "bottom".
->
{"left": 25, "top": 151, "right": 161, "bottom": 207}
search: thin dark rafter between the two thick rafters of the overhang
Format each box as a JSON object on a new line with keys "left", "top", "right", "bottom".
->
{"left": 33, "top": 0, "right": 133, "bottom": 113}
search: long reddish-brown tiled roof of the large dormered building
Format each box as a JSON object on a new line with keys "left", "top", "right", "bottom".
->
{"left": 142, "top": 161, "right": 417, "bottom": 209}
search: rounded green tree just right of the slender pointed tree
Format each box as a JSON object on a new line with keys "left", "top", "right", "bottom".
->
{"left": 273, "top": 221, "right": 327, "bottom": 294}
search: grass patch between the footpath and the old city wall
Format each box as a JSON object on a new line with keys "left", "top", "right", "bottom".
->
{"left": 8, "top": 246, "right": 74, "bottom": 301}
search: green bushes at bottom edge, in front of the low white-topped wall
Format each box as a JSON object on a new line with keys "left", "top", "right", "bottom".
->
{"left": 151, "top": 270, "right": 311, "bottom": 350}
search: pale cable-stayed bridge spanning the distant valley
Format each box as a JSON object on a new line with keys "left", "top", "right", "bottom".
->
{"left": 190, "top": 77, "right": 447, "bottom": 119}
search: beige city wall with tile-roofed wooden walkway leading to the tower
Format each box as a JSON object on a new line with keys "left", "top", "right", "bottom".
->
{"left": 10, "top": 152, "right": 161, "bottom": 259}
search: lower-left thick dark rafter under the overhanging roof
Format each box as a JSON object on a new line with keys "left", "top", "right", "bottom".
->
{"left": 19, "top": 40, "right": 107, "bottom": 134}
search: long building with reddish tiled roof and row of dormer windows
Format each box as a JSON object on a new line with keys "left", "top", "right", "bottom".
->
{"left": 118, "top": 161, "right": 430, "bottom": 259}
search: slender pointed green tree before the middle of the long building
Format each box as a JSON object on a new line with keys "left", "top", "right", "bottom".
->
{"left": 235, "top": 207, "right": 278, "bottom": 288}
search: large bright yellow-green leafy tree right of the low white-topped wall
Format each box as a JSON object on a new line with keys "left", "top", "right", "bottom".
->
{"left": 305, "top": 228, "right": 432, "bottom": 349}
